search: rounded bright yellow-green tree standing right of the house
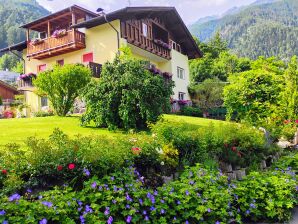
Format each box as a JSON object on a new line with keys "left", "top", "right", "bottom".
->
{"left": 224, "top": 63, "right": 282, "bottom": 124}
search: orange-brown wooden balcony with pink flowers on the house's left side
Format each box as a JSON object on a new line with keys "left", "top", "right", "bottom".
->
{"left": 27, "top": 30, "right": 86, "bottom": 59}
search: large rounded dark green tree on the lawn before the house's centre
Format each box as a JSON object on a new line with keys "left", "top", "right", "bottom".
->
{"left": 82, "top": 51, "right": 173, "bottom": 129}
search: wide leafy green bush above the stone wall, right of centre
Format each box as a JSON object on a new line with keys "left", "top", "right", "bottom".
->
{"left": 152, "top": 121, "right": 275, "bottom": 167}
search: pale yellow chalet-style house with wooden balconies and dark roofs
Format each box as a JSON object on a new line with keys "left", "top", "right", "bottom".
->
{"left": 0, "top": 5, "right": 201, "bottom": 114}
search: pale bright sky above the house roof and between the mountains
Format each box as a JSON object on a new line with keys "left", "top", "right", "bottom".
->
{"left": 37, "top": 0, "right": 255, "bottom": 24}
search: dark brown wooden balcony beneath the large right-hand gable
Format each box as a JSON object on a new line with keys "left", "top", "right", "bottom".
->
{"left": 121, "top": 22, "right": 171, "bottom": 60}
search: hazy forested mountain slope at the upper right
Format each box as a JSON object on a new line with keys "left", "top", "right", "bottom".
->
{"left": 190, "top": 0, "right": 298, "bottom": 59}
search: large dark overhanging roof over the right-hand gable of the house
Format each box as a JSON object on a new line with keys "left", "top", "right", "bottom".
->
{"left": 73, "top": 7, "right": 202, "bottom": 59}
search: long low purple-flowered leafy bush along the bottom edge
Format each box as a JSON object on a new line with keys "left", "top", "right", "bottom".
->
{"left": 0, "top": 166, "right": 240, "bottom": 223}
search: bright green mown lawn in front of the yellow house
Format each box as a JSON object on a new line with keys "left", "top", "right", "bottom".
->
{"left": 0, "top": 115, "right": 224, "bottom": 146}
